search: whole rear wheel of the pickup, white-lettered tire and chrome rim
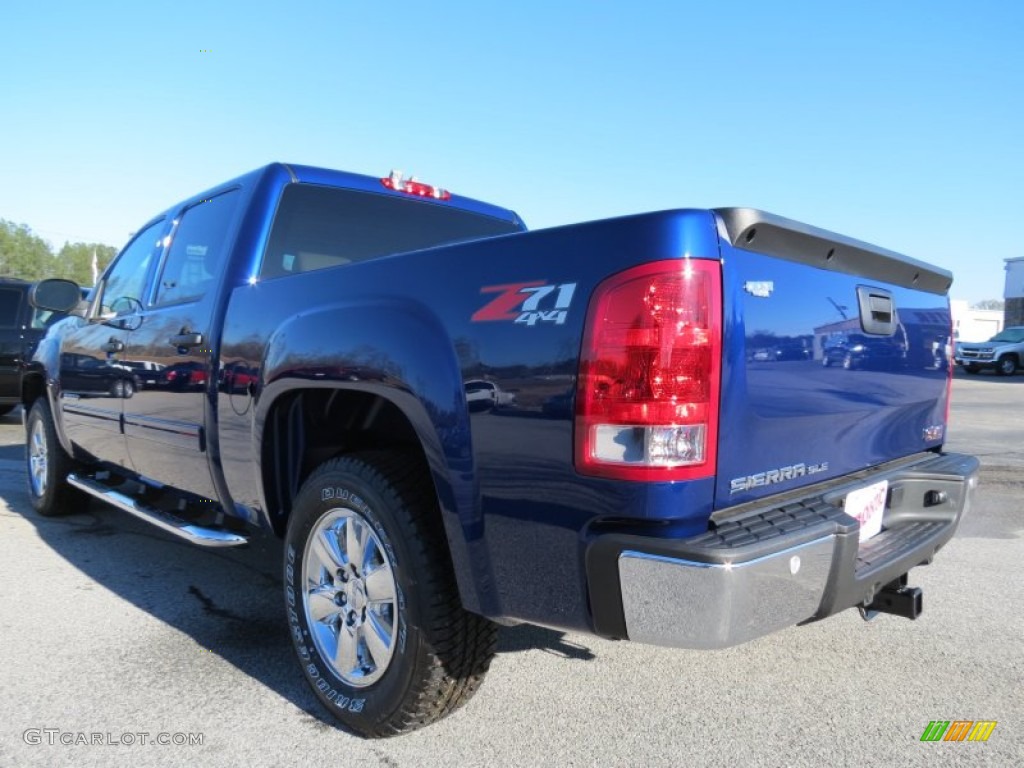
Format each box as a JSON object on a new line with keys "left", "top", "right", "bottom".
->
{"left": 285, "top": 454, "right": 497, "bottom": 737}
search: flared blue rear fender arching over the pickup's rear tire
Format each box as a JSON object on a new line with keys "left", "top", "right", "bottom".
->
{"left": 254, "top": 298, "right": 489, "bottom": 611}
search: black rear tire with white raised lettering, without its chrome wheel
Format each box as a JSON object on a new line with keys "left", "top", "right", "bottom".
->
{"left": 285, "top": 453, "right": 495, "bottom": 736}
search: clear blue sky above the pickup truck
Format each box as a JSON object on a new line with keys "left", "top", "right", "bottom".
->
{"left": 0, "top": 0, "right": 1024, "bottom": 301}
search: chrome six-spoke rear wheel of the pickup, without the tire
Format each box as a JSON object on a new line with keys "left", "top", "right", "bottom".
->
{"left": 302, "top": 508, "right": 398, "bottom": 688}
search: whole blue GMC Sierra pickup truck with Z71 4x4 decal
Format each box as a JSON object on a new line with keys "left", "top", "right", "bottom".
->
{"left": 28, "top": 164, "right": 978, "bottom": 736}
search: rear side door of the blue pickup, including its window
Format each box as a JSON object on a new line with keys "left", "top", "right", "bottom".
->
{"left": 124, "top": 189, "right": 239, "bottom": 499}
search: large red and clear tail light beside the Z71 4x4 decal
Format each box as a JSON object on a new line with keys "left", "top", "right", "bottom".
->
{"left": 575, "top": 258, "right": 722, "bottom": 481}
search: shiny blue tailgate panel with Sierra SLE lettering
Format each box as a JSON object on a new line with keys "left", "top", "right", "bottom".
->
{"left": 715, "top": 244, "right": 950, "bottom": 509}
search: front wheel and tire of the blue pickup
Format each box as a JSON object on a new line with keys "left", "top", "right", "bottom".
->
{"left": 25, "top": 397, "right": 87, "bottom": 517}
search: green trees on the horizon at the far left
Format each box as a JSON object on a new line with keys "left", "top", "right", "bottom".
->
{"left": 0, "top": 219, "right": 118, "bottom": 286}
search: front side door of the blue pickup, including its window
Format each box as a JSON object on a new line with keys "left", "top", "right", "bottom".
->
{"left": 58, "top": 219, "right": 167, "bottom": 469}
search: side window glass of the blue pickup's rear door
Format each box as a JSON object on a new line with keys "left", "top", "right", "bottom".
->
{"left": 156, "top": 189, "right": 239, "bottom": 306}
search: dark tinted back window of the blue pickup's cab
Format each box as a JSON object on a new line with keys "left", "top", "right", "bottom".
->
{"left": 260, "top": 184, "right": 519, "bottom": 279}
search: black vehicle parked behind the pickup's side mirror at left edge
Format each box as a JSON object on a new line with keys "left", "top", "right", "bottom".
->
{"left": 0, "top": 278, "right": 68, "bottom": 416}
